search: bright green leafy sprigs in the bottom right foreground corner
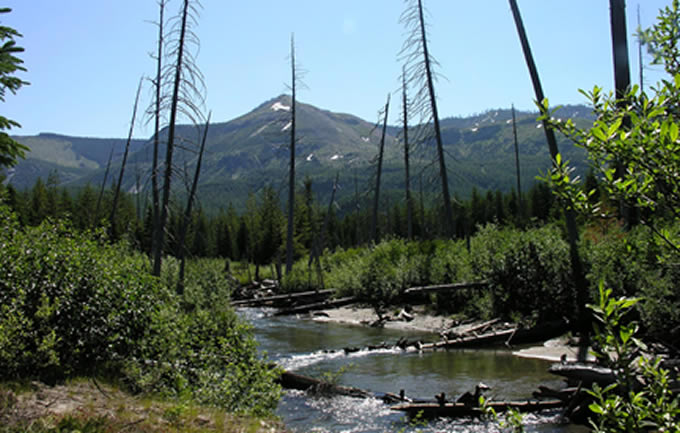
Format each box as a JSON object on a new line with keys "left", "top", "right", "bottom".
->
{"left": 590, "top": 283, "right": 680, "bottom": 433}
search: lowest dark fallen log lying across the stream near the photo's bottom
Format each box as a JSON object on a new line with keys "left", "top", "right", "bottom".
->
{"left": 390, "top": 400, "right": 565, "bottom": 419}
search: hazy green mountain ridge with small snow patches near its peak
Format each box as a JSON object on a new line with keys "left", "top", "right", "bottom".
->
{"left": 8, "top": 95, "right": 592, "bottom": 210}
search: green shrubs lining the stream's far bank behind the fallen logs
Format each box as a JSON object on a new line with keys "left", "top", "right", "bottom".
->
{"left": 283, "top": 224, "right": 680, "bottom": 341}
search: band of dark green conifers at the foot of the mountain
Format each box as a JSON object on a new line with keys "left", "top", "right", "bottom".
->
{"left": 0, "top": 169, "right": 598, "bottom": 265}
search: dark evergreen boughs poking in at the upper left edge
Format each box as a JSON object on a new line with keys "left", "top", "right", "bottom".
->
{"left": 0, "top": 8, "right": 28, "bottom": 167}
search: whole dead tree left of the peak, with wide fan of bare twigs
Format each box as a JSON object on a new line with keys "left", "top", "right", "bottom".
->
{"left": 152, "top": 0, "right": 204, "bottom": 276}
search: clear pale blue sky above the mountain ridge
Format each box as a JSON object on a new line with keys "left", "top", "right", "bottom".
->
{"left": 0, "top": 0, "right": 670, "bottom": 138}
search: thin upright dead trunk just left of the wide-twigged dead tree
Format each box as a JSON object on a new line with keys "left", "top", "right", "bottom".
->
{"left": 151, "top": 0, "right": 165, "bottom": 264}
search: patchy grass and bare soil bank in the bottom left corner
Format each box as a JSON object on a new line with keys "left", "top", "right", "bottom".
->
{"left": 0, "top": 379, "right": 286, "bottom": 433}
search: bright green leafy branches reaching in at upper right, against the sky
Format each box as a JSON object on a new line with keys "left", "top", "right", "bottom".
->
{"left": 542, "top": 0, "right": 680, "bottom": 256}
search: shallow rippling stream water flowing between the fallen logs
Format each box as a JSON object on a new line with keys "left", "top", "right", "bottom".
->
{"left": 240, "top": 309, "right": 581, "bottom": 433}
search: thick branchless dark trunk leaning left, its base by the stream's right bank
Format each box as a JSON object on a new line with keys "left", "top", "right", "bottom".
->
{"left": 509, "top": 0, "right": 590, "bottom": 361}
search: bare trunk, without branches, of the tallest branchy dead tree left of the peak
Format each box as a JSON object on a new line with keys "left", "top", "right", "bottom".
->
{"left": 153, "top": 0, "right": 189, "bottom": 276}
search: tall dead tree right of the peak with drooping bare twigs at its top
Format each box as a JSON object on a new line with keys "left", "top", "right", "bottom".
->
{"left": 399, "top": 0, "right": 455, "bottom": 237}
